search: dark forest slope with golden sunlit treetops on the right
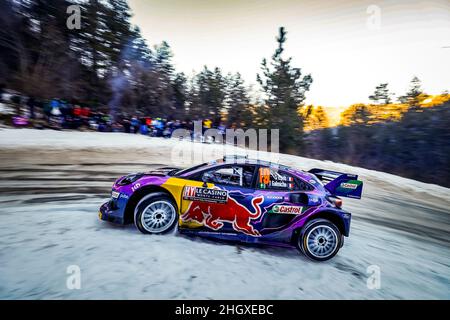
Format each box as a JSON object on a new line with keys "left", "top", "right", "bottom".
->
{"left": 302, "top": 95, "right": 450, "bottom": 187}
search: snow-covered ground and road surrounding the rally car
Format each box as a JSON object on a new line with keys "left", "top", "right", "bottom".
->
{"left": 0, "top": 129, "right": 450, "bottom": 299}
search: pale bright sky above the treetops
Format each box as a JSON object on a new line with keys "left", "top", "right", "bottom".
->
{"left": 129, "top": 0, "right": 450, "bottom": 109}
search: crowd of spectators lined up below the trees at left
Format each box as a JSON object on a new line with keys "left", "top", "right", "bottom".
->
{"left": 0, "top": 92, "right": 230, "bottom": 137}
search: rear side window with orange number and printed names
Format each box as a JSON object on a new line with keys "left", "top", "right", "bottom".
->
{"left": 257, "top": 167, "right": 311, "bottom": 191}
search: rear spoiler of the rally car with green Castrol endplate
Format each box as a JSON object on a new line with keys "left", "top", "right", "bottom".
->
{"left": 308, "top": 168, "right": 363, "bottom": 199}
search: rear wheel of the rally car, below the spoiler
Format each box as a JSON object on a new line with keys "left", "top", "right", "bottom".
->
{"left": 296, "top": 219, "right": 343, "bottom": 261}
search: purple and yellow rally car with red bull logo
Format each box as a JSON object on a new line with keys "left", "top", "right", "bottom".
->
{"left": 99, "top": 156, "right": 363, "bottom": 261}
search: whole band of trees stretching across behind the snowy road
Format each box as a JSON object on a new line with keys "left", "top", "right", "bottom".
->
{"left": 0, "top": 0, "right": 450, "bottom": 186}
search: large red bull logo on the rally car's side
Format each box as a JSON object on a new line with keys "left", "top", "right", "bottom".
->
{"left": 181, "top": 196, "right": 264, "bottom": 236}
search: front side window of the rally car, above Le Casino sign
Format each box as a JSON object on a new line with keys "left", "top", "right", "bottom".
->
{"left": 200, "top": 165, "right": 255, "bottom": 188}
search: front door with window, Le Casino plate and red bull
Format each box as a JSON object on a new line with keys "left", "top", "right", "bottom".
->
{"left": 181, "top": 164, "right": 263, "bottom": 236}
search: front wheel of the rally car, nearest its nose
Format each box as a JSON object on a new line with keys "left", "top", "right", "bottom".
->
{"left": 134, "top": 192, "right": 178, "bottom": 234}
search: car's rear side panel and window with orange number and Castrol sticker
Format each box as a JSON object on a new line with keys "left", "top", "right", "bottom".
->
{"left": 255, "top": 166, "right": 312, "bottom": 235}
